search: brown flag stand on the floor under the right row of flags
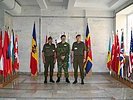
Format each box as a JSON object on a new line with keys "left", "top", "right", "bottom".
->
{"left": 111, "top": 71, "right": 133, "bottom": 89}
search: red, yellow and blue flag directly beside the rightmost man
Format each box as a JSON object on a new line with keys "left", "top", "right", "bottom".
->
{"left": 85, "top": 24, "right": 92, "bottom": 73}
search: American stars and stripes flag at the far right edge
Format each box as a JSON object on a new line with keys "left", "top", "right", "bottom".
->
{"left": 128, "top": 30, "right": 133, "bottom": 77}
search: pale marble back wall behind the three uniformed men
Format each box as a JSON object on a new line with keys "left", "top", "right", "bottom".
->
{"left": 13, "top": 8, "right": 114, "bottom": 72}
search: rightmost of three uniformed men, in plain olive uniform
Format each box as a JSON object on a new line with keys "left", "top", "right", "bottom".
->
{"left": 72, "top": 34, "right": 86, "bottom": 84}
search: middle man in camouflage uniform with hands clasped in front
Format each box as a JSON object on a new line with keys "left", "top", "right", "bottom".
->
{"left": 56, "top": 35, "right": 70, "bottom": 83}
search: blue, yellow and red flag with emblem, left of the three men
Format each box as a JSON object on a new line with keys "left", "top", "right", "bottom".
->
{"left": 30, "top": 23, "right": 38, "bottom": 76}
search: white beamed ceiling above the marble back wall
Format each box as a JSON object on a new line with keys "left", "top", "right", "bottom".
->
{"left": 16, "top": 0, "right": 128, "bottom": 10}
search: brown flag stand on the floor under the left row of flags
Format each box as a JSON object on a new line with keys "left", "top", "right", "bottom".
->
{"left": 0, "top": 72, "right": 19, "bottom": 88}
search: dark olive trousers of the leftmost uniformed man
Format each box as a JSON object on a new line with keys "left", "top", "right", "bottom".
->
{"left": 44, "top": 56, "right": 54, "bottom": 77}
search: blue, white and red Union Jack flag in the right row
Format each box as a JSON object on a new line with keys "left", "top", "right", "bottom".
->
{"left": 118, "top": 31, "right": 125, "bottom": 77}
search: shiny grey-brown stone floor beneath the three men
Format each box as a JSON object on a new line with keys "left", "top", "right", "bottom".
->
{"left": 0, "top": 74, "right": 133, "bottom": 100}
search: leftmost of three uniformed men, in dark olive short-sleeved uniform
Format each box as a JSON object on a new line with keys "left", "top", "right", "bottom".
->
{"left": 42, "top": 37, "right": 56, "bottom": 83}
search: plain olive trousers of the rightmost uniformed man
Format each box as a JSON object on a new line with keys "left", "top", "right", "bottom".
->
{"left": 73, "top": 56, "right": 84, "bottom": 79}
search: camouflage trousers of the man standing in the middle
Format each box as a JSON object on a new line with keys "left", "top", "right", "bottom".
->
{"left": 57, "top": 61, "right": 69, "bottom": 78}
